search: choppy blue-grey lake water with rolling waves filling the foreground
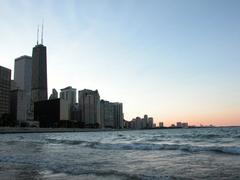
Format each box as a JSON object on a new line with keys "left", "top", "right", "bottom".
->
{"left": 0, "top": 128, "right": 240, "bottom": 180}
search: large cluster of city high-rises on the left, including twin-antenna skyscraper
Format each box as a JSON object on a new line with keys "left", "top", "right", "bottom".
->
{"left": 0, "top": 28, "right": 124, "bottom": 129}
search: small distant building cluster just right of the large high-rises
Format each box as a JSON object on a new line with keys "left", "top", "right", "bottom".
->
{"left": 125, "top": 115, "right": 156, "bottom": 129}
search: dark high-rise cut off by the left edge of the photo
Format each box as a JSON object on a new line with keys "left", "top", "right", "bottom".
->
{"left": 0, "top": 66, "right": 11, "bottom": 118}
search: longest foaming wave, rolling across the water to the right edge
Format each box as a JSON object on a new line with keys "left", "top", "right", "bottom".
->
{"left": 45, "top": 139, "right": 240, "bottom": 155}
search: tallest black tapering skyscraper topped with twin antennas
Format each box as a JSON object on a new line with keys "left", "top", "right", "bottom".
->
{"left": 31, "top": 25, "right": 48, "bottom": 107}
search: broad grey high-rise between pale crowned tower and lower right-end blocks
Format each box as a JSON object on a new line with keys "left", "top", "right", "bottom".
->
{"left": 78, "top": 89, "right": 101, "bottom": 128}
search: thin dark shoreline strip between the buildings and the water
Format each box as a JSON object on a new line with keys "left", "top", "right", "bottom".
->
{"left": 0, "top": 126, "right": 240, "bottom": 134}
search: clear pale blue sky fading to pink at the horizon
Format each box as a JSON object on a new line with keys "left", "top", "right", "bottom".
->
{"left": 0, "top": 0, "right": 240, "bottom": 125}
